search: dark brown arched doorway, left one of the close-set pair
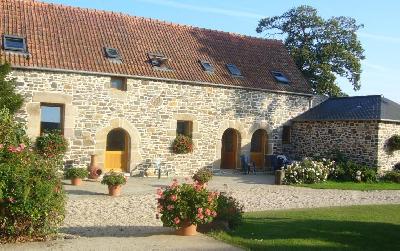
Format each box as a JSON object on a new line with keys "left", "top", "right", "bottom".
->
{"left": 221, "top": 128, "right": 241, "bottom": 169}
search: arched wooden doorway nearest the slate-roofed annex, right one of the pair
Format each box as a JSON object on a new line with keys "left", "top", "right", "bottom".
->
{"left": 250, "top": 129, "right": 268, "bottom": 169}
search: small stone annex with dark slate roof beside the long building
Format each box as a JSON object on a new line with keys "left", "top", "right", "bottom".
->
{"left": 285, "top": 95, "right": 400, "bottom": 170}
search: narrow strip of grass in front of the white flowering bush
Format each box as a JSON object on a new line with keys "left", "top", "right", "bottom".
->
{"left": 295, "top": 180, "right": 400, "bottom": 191}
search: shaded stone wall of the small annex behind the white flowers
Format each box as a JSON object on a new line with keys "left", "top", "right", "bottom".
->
{"left": 287, "top": 121, "right": 380, "bottom": 166}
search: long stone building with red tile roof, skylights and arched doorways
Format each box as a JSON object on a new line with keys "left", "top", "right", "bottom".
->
{"left": 0, "top": 0, "right": 396, "bottom": 175}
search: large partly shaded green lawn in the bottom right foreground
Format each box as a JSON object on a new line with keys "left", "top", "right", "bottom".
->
{"left": 211, "top": 205, "right": 400, "bottom": 251}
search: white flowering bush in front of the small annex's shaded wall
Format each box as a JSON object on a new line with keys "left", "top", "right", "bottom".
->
{"left": 283, "top": 158, "right": 335, "bottom": 184}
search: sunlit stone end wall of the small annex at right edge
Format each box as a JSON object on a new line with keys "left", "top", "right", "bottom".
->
{"left": 378, "top": 122, "right": 400, "bottom": 170}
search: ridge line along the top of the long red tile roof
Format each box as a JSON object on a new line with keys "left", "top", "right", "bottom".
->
{"left": 17, "top": 0, "right": 283, "bottom": 45}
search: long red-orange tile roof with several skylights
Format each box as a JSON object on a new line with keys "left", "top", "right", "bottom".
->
{"left": 0, "top": 0, "right": 311, "bottom": 94}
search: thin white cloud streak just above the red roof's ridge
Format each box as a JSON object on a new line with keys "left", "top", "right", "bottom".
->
{"left": 136, "top": 0, "right": 264, "bottom": 19}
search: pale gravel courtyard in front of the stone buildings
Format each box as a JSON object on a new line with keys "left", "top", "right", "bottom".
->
{"left": 0, "top": 175, "right": 400, "bottom": 250}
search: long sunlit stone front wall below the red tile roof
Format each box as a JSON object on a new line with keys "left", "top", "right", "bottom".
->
{"left": 12, "top": 67, "right": 310, "bottom": 175}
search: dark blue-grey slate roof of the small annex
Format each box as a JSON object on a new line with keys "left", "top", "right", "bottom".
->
{"left": 292, "top": 95, "right": 400, "bottom": 122}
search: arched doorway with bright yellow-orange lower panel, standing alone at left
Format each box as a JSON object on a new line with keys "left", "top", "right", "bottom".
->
{"left": 104, "top": 128, "right": 130, "bottom": 172}
